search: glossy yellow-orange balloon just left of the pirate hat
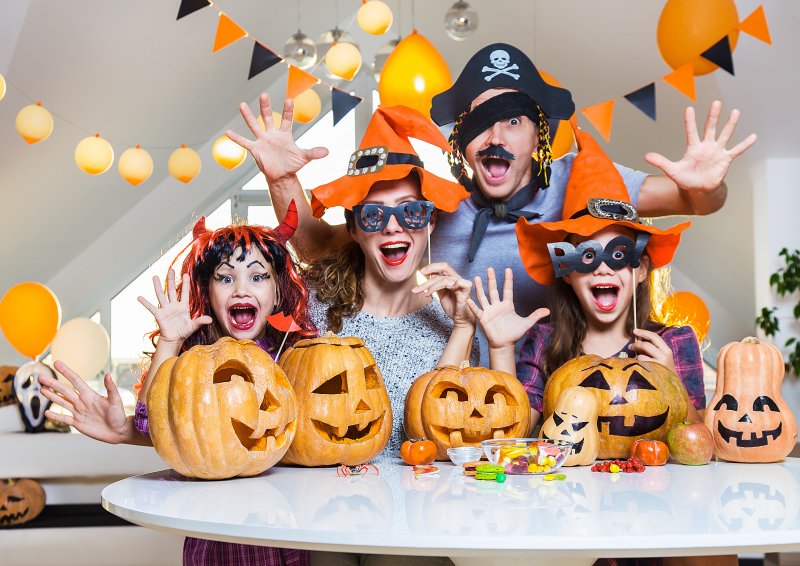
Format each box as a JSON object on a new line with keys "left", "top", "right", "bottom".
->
{"left": 378, "top": 31, "right": 453, "bottom": 116}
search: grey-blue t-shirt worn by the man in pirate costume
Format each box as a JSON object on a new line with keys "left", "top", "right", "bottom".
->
{"left": 431, "top": 153, "right": 647, "bottom": 367}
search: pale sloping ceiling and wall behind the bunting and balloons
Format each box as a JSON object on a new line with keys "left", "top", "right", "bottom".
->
{"left": 0, "top": 0, "right": 800, "bottom": 362}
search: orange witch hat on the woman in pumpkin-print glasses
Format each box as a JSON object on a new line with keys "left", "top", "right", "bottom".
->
{"left": 311, "top": 106, "right": 469, "bottom": 218}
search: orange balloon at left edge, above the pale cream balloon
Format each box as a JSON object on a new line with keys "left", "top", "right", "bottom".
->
{"left": 0, "top": 281, "right": 61, "bottom": 359}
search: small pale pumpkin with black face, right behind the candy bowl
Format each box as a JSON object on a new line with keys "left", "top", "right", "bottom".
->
{"left": 542, "top": 387, "right": 600, "bottom": 466}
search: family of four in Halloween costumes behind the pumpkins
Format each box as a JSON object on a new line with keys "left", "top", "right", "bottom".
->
{"left": 42, "top": 43, "right": 756, "bottom": 565}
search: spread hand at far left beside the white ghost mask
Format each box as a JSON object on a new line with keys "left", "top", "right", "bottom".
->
{"left": 39, "top": 361, "right": 133, "bottom": 444}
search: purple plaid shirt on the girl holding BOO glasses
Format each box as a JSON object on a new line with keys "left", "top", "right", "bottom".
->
{"left": 517, "top": 323, "right": 706, "bottom": 413}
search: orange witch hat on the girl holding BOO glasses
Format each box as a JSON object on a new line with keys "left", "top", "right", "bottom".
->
{"left": 516, "top": 120, "right": 692, "bottom": 285}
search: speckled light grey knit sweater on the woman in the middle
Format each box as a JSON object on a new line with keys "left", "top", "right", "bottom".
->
{"left": 308, "top": 292, "right": 479, "bottom": 459}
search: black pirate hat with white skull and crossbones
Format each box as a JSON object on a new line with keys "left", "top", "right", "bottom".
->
{"left": 431, "top": 43, "right": 575, "bottom": 126}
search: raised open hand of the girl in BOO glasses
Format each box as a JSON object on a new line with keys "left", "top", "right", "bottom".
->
{"left": 467, "top": 267, "right": 550, "bottom": 348}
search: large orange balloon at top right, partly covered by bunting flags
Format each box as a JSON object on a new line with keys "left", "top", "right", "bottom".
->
{"left": 656, "top": 0, "right": 739, "bottom": 75}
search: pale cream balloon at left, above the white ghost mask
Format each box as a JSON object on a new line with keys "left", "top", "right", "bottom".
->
{"left": 50, "top": 317, "right": 111, "bottom": 380}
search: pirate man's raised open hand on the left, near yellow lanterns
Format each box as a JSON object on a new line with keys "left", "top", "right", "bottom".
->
{"left": 225, "top": 93, "right": 328, "bottom": 184}
